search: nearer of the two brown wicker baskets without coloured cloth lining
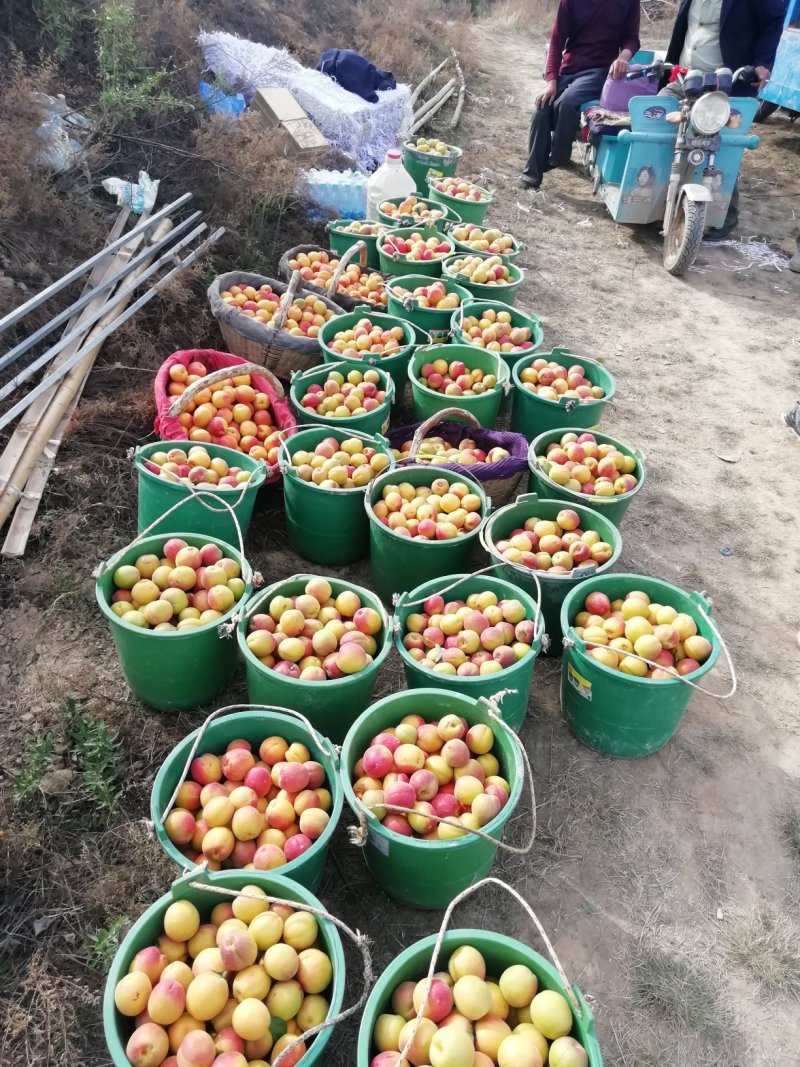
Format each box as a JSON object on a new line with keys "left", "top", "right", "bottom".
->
{"left": 208, "top": 271, "right": 342, "bottom": 380}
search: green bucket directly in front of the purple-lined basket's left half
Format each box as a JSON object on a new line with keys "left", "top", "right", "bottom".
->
{"left": 364, "top": 465, "right": 491, "bottom": 604}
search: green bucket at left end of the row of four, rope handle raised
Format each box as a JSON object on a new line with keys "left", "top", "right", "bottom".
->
{"left": 95, "top": 532, "right": 253, "bottom": 712}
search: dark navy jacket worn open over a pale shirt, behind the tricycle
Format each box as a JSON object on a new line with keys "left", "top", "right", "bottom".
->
{"left": 667, "top": 0, "right": 787, "bottom": 70}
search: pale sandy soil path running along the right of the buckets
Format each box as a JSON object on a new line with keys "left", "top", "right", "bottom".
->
{"left": 452, "top": 20, "right": 800, "bottom": 1065}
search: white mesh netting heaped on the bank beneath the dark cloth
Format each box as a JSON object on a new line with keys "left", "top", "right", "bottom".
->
{"left": 197, "top": 33, "right": 412, "bottom": 171}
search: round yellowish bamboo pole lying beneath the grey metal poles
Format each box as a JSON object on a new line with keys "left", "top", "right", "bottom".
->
{"left": 0, "top": 220, "right": 172, "bottom": 529}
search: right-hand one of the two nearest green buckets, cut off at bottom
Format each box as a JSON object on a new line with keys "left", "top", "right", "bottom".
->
{"left": 355, "top": 919, "right": 603, "bottom": 1067}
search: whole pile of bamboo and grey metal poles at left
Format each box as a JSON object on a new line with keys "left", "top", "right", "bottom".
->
{"left": 0, "top": 193, "right": 224, "bottom": 556}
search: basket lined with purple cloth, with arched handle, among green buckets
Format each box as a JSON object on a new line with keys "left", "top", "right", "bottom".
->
{"left": 389, "top": 408, "right": 529, "bottom": 506}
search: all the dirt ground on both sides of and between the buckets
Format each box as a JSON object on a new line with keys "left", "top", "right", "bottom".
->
{"left": 0, "top": 8, "right": 800, "bottom": 1067}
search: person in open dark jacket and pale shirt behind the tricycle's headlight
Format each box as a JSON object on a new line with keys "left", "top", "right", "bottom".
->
{"left": 661, "top": 0, "right": 787, "bottom": 238}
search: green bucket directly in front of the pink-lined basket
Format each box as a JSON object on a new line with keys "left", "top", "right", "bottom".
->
{"left": 133, "top": 441, "right": 267, "bottom": 542}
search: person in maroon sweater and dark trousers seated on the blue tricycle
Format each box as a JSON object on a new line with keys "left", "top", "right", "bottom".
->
{"left": 519, "top": 0, "right": 639, "bottom": 189}
